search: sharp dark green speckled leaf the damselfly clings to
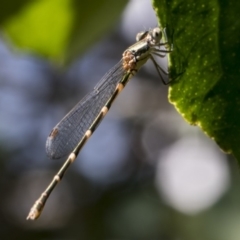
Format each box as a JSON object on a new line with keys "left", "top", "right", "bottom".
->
{"left": 153, "top": 0, "right": 240, "bottom": 161}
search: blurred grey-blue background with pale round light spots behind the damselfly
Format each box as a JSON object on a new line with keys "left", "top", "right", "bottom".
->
{"left": 0, "top": 0, "right": 240, "bottom": 240}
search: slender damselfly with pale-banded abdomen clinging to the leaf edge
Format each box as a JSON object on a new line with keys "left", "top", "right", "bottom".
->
{"left": 27, "top": 27, "right": 171, "bottom": 220}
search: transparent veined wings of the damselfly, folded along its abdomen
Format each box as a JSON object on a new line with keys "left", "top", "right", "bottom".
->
{"left": 46, "top": 61, "right": 126, "bottom": 159}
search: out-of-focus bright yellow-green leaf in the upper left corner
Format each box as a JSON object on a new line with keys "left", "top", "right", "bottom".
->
{"left": 0, "top": 0, "right": 127, "bottom": 62}
